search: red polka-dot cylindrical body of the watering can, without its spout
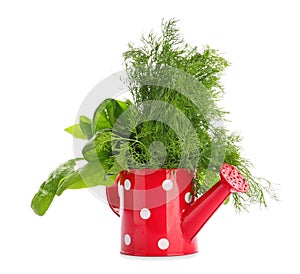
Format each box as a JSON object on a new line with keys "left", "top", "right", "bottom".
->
{"left": 116, "top": 168, "right": 198, "bottom": 256}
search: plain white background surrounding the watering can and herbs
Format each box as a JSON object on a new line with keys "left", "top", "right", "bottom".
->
{"left": 0, "top": 0, "right": 300, "bottom": 274}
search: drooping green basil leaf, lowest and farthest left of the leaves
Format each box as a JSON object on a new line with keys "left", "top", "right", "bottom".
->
{"left": 31, "top": 159, "right": 77, "bottom": 216}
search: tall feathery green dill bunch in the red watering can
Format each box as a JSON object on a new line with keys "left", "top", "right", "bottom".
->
{"left": 122, "top": 19, "right": 276, "bottom": 211}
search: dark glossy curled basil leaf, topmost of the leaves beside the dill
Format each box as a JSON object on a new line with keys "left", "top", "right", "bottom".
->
{"left": 93, "top": 99, "right": 129, "bottom": 133}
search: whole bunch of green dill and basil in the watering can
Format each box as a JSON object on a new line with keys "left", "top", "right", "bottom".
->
{"left": 32, "top": 19, "right": 276, "bottom": 215}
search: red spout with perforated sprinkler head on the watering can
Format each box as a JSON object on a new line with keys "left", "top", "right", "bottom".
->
{"left": 182, "top": 163, "right": 249, "bottom": 240}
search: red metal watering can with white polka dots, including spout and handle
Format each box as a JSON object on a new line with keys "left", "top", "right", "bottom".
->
{"left": 106, "top": 163, "right": 249, "bottom": 256}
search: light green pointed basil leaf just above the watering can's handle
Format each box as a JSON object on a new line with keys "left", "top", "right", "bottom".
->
{"left": 57, "top": 161, "right": 114, "bottom": 195}
